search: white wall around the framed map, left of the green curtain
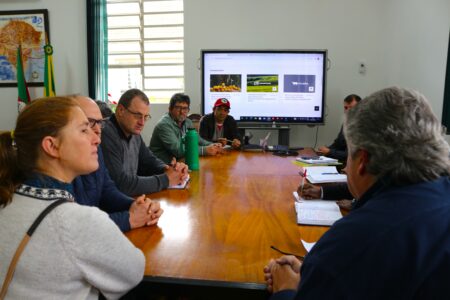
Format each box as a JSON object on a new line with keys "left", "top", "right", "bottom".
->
{"left": 0, "top": 0, "right": 88, "bottom": 130}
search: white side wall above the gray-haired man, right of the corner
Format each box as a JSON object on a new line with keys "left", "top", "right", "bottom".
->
{"left": 385, "top": 0, "right": 450, "bottom": 123}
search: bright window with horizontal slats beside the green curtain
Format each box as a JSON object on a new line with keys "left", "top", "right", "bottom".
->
{"left": 107, "top": 0, "right": 184, "bottom": 103}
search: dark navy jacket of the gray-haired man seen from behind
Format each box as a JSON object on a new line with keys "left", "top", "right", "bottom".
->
{"left": 272, "top": 177, "right": 450, "bottom": 300}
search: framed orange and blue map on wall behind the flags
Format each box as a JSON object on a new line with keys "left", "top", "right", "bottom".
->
{"left": 0, "top": 9, "right": 50, "bottom": 87}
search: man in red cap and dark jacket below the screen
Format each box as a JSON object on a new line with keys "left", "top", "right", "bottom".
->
{"left": 200, "top": 98, "right": 241, "bottom": 148}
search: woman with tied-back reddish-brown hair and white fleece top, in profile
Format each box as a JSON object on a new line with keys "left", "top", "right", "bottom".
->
{"left": 0, "top": 97, "right": 145, "bottom": 299}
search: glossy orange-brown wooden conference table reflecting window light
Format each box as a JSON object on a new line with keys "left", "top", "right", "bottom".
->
{"left": 127, "top": 151, "right": 328, "bottom": 298}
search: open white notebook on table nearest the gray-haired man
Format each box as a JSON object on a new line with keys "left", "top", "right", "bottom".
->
{"left": 293, "top": 192, "right": 342, "bottom": 226}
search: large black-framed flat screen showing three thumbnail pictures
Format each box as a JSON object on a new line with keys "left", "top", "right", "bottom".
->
{"left": 201, "top": 50, "right": 327, "bottom": 124}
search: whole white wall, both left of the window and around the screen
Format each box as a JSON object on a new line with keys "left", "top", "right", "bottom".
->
{"left": 0, "top": 0, "right": 450, "bottom": 146}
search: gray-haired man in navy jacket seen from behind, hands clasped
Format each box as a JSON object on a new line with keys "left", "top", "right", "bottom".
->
{"left": 264, "top": 87, "right": 450, "bottom": 300}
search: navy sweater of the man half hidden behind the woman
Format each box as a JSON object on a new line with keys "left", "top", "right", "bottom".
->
{"left": 72, "top": 147, "right": 134, "bottom": 232}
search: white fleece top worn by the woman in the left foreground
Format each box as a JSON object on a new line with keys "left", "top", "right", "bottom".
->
{"left": 0, "top": 186, "right": 145, "bottom": 299}
